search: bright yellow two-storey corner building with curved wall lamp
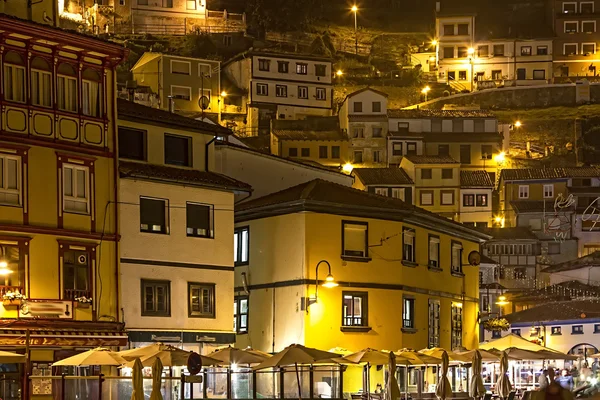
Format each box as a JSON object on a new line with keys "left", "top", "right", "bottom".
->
{"left": 235, "top": 179, "right": 489, "bottom": 391}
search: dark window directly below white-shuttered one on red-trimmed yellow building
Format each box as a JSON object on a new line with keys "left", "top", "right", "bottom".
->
{"left": 63, "top": 250, "right": 91, "bottom": 300}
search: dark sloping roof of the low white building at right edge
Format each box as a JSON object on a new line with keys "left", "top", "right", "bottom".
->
{"left": 504, "top": 300, "right": 600, "bottom": 324}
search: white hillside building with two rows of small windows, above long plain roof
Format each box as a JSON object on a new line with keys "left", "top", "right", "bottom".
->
{"left": 223, "top": 50, "right": 333, "bottom": 136}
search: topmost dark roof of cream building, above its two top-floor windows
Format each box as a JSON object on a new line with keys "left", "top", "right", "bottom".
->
{"left": 117, "top": 99, "right": 232, "bottom": 135}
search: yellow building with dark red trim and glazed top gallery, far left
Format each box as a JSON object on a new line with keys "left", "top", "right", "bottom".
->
{"left": 0, "top": 15, "right": 127, "bottom": 397}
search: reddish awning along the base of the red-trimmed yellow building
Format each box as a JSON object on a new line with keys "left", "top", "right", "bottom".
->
{"left": 0, "top": 329, "right": 127, "bottom": 347}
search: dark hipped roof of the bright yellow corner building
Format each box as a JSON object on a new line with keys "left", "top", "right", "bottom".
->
{"left": 235, "top": 179, "right": 489, "bottom": 242}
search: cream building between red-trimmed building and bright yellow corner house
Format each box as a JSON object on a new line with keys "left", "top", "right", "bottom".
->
{"left": 118, "top": 100, "right": 251, "bottom": 354}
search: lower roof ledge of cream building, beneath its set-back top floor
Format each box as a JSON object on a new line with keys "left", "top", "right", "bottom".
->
{"left": 119, "top": 161, "right": 252, "bottom": 192}
